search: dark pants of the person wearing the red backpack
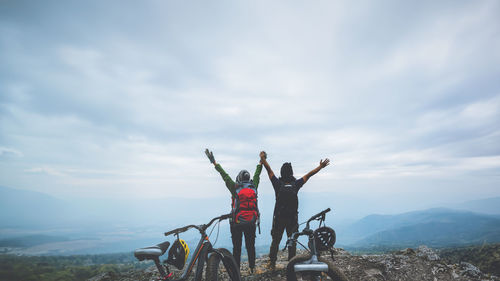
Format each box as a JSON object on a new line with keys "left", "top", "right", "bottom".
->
{"left": 231, "top": 224, "right": 255, "bottom": 268}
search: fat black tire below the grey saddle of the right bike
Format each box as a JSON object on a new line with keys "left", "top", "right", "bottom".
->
{"left": 286, "top": 254, "right": 349, "bottom": 281}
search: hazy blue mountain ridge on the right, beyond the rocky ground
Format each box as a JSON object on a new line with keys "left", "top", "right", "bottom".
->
{"left": 338, "top": 208, "right": 500, "bottom": 248}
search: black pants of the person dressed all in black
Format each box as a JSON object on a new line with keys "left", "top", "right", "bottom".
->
{"left": 269, "top": 216, "right": 299, "bottom": 263}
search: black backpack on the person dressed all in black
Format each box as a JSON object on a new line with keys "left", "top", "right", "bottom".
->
{"left": 274, "top": 179, "right": 299, "bottom": 216}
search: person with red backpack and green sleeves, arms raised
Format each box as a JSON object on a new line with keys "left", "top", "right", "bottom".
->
{"left": 205, "top": 149, "right": 262, "bottom": 273}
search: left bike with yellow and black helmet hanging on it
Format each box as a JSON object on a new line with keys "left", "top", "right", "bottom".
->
{"left": 134, "top": 214, "right": 241, "bottom": 281}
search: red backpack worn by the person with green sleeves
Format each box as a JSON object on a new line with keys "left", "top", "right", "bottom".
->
{"left": 232, "top": 182, "right": 260, "bottom": 224}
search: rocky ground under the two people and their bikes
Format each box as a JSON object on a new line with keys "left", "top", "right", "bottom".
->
{"left": 89, "top": 246, "right": 500, "bottom": 281}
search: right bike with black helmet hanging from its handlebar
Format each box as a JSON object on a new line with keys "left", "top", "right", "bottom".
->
{"left": 285, "top": 208, "right": 348, "bottom": 281}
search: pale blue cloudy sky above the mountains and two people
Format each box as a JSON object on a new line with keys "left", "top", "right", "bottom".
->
{"left": 0, "top": 0, "right": 500, "bottom": 206}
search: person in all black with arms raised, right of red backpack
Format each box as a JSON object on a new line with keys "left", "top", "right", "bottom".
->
{"left": 260, "top": 151, "right": 330, "bottom": 269}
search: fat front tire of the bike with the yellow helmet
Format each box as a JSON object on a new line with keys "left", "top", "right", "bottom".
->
{"left": 205, "top": 248, "right": 241, "bottom": 281}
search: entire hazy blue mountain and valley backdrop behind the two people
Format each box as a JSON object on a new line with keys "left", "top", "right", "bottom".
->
{"left": 0, "top": 187, "right": 500, "bottom": 254}
